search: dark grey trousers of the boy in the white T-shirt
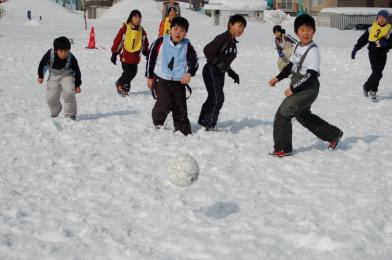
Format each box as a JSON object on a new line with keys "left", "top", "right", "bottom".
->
{"left": 273, "top": 85, "right": 340, "bottom": 152}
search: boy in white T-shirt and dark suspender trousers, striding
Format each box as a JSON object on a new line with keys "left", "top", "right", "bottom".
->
{"left": 269, "top": 14, "right": 343, "bottom": 157}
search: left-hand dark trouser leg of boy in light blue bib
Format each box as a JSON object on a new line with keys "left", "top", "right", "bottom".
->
{"left": 152, "top": 79, "right": 173, "bottom": 125}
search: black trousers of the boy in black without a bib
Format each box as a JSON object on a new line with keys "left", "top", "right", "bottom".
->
{"left": 198, "top": 63, "right": 225, "bottom": 128}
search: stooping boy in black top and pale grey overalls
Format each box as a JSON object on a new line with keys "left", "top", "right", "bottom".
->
{"left": 37, "top": 36, "right": 82, "bottom": 120}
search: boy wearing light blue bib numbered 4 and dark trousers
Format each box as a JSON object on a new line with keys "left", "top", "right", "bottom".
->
{"left": 146, "top": 17, "right": 199, "bottom": 135}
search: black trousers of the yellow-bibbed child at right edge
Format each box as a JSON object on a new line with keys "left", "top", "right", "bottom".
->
{"left": 364, "top": 50, "right": 387, "bottom": 92}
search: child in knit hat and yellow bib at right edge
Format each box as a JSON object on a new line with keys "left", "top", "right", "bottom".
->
{"left": 351, "top": 10, "right": 392, "bottom": 101}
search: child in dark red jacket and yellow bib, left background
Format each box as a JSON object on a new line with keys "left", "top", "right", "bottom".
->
{"left": 110, "top": 10, "right": 148, "bottom": 97}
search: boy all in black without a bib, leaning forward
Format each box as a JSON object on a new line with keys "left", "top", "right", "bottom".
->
{"left": 198, "top": 14, "right": 246, "bottom": 131}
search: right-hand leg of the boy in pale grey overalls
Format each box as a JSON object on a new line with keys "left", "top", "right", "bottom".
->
{"left": 60, "top": 75, "right": 77, "bottom": 117}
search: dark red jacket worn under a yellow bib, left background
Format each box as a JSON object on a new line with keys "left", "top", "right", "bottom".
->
{"left": 112, "top": 23, "right": 149, "bottom": 64}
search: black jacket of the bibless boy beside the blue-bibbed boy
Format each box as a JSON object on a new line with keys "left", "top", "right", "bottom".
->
{"left": 203, "top": 30, "right": 238, "bottom": 73}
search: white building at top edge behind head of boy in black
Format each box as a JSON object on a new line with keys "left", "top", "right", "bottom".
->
{"left": 204, "top": 0, "right": 267, "bottom": 25}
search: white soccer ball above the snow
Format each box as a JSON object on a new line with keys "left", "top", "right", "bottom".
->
{"left": 167, "top": 154, "right": 199, "bottom": 187}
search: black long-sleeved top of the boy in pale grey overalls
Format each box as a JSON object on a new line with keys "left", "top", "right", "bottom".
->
{"left": 38, "top": 49, "right": 82, "bottom": 87}
